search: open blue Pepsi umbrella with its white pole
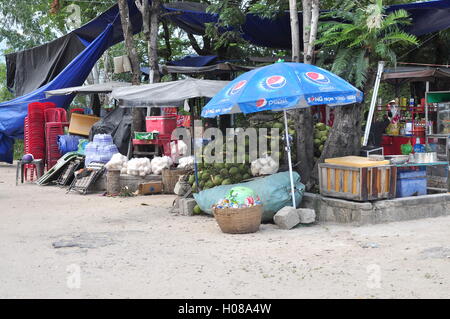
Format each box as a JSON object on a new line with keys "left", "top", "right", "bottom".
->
{"left": 201, "top": 62, "right": 363, "bottom": 207}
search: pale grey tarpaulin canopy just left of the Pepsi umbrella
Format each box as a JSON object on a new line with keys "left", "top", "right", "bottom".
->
{"left": 111, "top": 78, "right": 229, "bottom": 107}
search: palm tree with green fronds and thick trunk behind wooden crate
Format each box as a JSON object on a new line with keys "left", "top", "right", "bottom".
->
{"left": 312, "top": 0, "right": 418, "bottom": 184}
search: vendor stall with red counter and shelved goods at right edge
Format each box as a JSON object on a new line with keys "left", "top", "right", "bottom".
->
{"left": 375, "top": 66, "right": 450, "bottom": 156}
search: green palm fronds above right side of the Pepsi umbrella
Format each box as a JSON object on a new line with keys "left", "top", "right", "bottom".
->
{"left": 316, "top": 0, "right": 418, "bottom": 88}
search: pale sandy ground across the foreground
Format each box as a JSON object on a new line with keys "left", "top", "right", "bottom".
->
{"left": 0, "top": 164, "right": 450, "bottom": 298}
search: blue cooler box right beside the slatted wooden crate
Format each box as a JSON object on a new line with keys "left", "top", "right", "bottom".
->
{"left": 397, "top": 168, "right": 427, "bottom": 197}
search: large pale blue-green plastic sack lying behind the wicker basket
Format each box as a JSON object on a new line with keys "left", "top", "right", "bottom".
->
{"left": 194, "top": 172, "right": 305, "bottom": 222}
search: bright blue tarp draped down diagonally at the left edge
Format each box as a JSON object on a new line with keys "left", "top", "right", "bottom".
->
{"left": 0, "top": 24, "right": 113, "bottom": 163}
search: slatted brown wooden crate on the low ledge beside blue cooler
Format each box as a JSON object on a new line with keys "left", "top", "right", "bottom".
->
{"left": 319, "top": 163, "right": 397, "bottom": 201}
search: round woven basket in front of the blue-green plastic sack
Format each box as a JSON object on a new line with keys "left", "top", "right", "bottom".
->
{"left": 214, "top": 205, "right": 262, "bottom": 234}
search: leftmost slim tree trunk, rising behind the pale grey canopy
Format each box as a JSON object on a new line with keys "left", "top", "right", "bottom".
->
{"left": 118, "top": 0, "right": 144, "bottom": 152}
